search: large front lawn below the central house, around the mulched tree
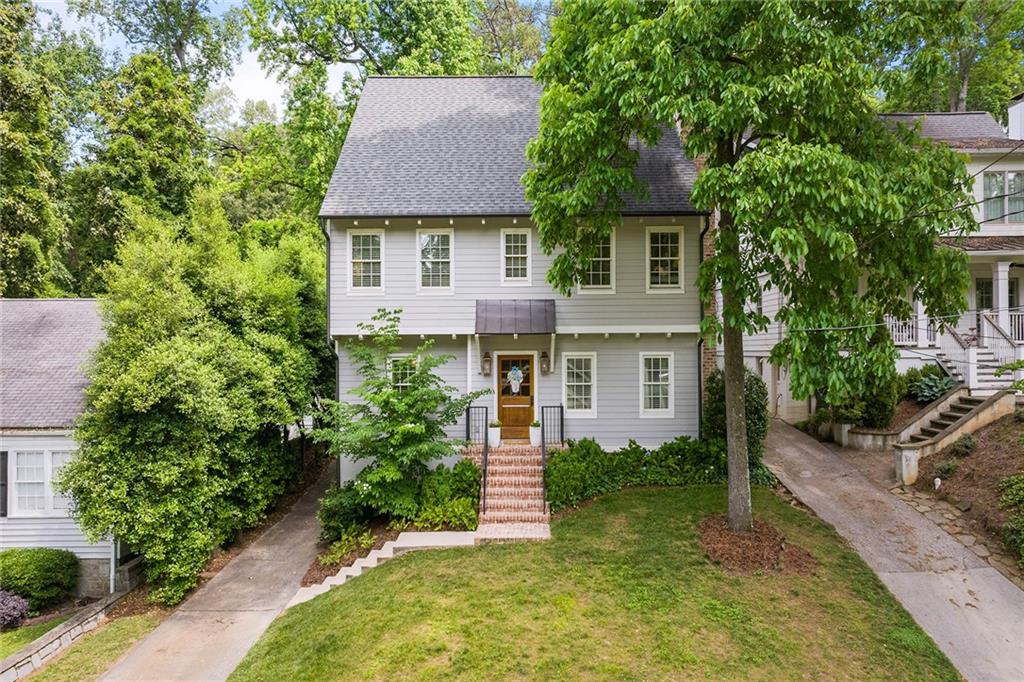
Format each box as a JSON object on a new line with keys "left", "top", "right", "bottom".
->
{"left": 231, "top": 486, "right": 959, "bottom": 681}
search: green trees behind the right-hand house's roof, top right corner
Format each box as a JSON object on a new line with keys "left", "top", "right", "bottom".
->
{"left": 883, "top": 0, "right": 1024, "bottom": 123}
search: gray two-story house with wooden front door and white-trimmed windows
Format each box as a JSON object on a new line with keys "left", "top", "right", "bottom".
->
{"left": 321, "top": 77, "right": 706, "bottom": 478}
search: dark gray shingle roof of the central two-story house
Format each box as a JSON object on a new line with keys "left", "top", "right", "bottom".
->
{"left": 319, "top": 77, "right": 696, "bottom": 217}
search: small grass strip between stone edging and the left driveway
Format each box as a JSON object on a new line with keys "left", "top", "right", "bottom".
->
{"left": 32, "top": 612, "right": 163, "bottom": 682}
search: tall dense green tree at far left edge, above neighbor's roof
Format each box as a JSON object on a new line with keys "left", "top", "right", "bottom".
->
{"left": 0, "top": 1, "right": 62, "bottom": 296}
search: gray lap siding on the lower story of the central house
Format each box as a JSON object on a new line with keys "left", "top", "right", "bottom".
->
{"left": 339, "top": 334, "right": 699, "bottom": 464}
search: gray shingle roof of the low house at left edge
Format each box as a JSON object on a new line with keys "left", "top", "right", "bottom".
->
{"left": 0, "top": 298, "right": 103, "bottom": 428}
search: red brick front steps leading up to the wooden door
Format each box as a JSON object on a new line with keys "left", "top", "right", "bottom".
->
{"left": 476, "top": 445, "right": 551, "bottom": 542}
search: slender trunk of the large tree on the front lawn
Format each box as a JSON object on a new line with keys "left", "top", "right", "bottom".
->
{"left": 718, "top": 205, "right": 754, "bottom": 532}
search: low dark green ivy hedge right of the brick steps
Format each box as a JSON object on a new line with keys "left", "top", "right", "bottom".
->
{"left": 545, "top": 436, "right": 774, "bottom": 511}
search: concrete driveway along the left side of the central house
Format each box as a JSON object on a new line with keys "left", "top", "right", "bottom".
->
{"left": 101, "top": 467, "right": 334, "bottom": 682}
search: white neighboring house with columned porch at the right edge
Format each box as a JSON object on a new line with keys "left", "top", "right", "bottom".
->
{"left": 743, "top": 102, "right": 1024, "bottom": 421}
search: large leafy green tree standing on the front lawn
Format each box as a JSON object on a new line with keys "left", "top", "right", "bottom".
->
{"left": 525, "top": 0, "right": 975, "bottom": 530}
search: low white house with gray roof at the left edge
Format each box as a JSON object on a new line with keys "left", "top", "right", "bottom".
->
{"left": 0, "top": 299, "right": 138, "bottom": 596}
